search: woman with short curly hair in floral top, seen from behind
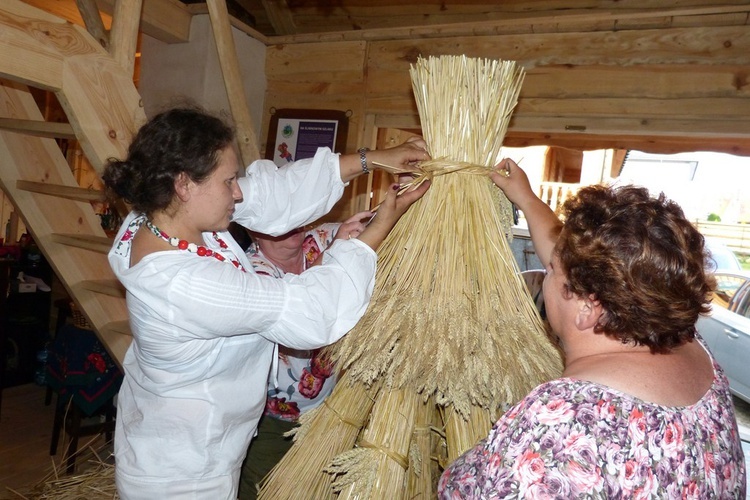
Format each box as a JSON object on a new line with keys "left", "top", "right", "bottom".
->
{"left": 439, "top": 160, "right": 745, "bottom": 499}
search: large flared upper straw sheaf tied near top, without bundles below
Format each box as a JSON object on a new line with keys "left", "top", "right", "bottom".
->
{"left": 330, "top": 56, "right": 562, "bottom": 419}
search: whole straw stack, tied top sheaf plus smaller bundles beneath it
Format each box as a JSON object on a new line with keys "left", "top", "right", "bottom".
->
{"left": 261, "top": 56, "right": 562, "bottom": 499}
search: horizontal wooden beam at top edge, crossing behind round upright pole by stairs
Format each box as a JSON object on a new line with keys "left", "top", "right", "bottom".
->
{"left": 96, "top": 0, "right": 193, "bottom": 43}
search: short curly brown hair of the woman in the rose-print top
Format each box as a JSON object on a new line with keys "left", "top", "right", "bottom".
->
{"left": 555, "top": 185, "right": 715, "bottom": 352}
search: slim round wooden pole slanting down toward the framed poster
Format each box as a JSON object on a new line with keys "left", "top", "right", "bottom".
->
{"left": 206, "top": 0, "right": 260, "bottom": 165}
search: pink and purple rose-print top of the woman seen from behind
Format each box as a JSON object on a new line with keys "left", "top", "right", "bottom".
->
{"left": 438, "top": 344, "right": 745, "bottom": 500}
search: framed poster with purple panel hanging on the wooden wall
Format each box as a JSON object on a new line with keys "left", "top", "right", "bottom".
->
{"left": 266, "top": 109, "right": 350, "bottom": 167}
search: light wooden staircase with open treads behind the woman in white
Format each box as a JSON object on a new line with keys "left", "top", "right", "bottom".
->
{"left": 0, "top": 0, "right": 145, "bottom": 363}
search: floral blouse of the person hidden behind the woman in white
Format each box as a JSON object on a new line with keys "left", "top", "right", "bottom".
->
{"left": 247, "top": 224, "right": 340, "bottom": 422}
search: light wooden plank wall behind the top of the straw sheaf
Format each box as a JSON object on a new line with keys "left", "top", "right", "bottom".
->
{"left": 266, "top": 18, "right": 750, "bottom": 155}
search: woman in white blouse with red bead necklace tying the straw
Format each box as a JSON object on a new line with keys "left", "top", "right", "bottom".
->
{"left": 103, "top": 107, "right": 429, "bottom": 500}
